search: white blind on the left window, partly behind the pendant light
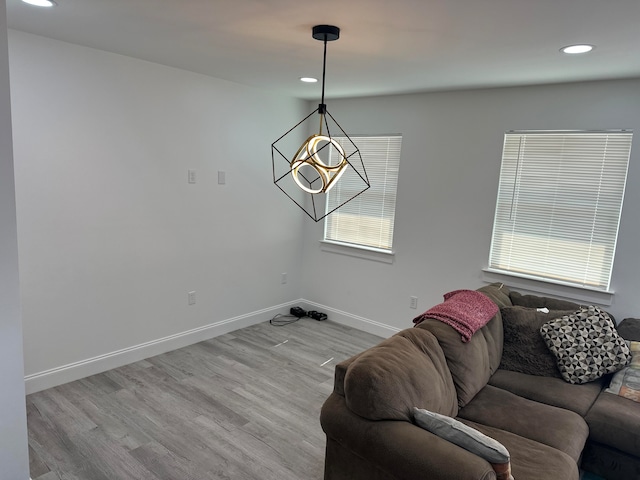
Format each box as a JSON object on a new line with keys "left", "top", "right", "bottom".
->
{"left": 324, "top": 135, "right": 402, "bottom": 251}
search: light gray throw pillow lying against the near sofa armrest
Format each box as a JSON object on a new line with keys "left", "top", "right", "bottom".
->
{"left": 413, "top": 407, "right": 510, "bottom": 464}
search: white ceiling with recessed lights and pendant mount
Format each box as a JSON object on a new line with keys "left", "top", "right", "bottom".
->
{"left": 6, "top": 0, "right": 640, "bottom": 99}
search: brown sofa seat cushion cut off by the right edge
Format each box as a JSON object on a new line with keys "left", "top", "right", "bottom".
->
{"left": 585, "top": 392, "right": 640, "bottom": 457}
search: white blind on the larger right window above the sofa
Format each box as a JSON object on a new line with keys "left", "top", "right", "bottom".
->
{"left": 489, "top": 131, "right": 632, "bottom": 291}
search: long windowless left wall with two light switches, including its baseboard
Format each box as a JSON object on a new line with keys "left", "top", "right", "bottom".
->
{"left": 9, "top": 31, "right": 307, "bottom": 391}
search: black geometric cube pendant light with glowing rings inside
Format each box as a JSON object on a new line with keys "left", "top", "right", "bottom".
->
{"left": 271, "top": 25, "right": 370, "bottom": 222}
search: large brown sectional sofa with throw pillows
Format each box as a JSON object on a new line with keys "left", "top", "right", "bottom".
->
{"left": 320, "top": 284, "right": 640, "bottom": 480}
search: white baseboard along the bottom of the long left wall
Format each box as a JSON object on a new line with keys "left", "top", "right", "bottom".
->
{"left": 25, "top": 300, "right": 296, "bottom": 394}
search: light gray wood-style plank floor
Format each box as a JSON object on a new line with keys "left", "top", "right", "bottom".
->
{"left": 27, "top": 318, "right": 381, "bottom": 480}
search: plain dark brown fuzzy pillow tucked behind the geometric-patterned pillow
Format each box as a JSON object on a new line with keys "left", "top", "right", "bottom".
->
{"left": 500, "top": 306, "right": 575, "bottom": 378}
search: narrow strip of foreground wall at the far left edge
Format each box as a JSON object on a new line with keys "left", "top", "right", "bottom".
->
{"left": 0, "top": 0, "right": 29, "bottom": 480}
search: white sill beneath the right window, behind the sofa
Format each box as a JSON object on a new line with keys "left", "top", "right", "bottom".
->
{"left": 482, "top": 268, "right": 615, "bottom": 306}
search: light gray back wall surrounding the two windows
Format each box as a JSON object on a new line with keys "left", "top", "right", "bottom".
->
{"left": 303, "top": 80, "right": 640, "bottom": 333}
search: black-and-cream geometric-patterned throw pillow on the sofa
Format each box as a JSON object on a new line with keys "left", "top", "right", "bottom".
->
{"left": 540, "top": 306, "right": 631, "bottom": 384}
